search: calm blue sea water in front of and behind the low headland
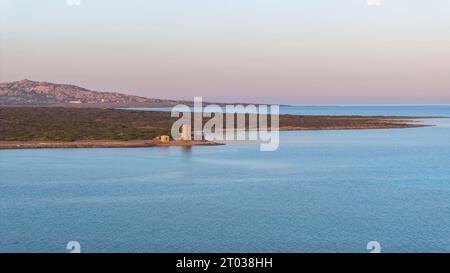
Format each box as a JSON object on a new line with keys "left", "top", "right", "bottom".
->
{"left": 0, "top": 106, "right": 450, "bottom": 252}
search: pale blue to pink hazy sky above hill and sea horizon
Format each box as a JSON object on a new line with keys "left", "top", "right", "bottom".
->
{"left": 0, "top": 0, "right": 450, "bottom": 104}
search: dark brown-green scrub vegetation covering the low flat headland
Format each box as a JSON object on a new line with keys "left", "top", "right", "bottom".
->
{"left": 0, "top": 107, "right": 434, "bottom": 141}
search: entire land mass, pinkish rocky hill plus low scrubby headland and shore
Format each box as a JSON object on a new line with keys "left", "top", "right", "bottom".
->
{"left": 0, "top": 80, "right": 442, "bottom": 149}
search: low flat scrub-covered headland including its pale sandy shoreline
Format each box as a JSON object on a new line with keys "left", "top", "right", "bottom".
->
{"left": 0, "top": 107, "right": 448, "bottom": 149}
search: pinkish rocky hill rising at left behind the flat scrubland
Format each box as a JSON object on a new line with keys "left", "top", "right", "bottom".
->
{"left": 0, "top": 79, "right": 181, "bottom": 107}
